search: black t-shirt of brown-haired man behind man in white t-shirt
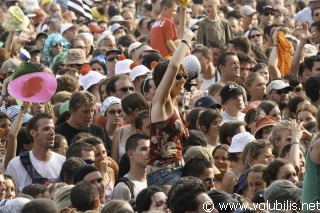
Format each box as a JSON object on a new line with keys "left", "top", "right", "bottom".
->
{"left": 55, "top": 122, "right": 112, "bottom": 153}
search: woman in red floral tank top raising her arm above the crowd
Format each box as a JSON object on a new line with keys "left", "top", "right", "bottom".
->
{"left": 147, "top": 30, "right": 195, "bottom": 186}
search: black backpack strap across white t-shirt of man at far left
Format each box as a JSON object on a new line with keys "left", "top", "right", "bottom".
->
{"left": 20, "top": 151, "right": 48, "bottom": 184}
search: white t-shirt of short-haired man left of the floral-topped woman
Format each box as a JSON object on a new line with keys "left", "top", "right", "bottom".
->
{"left": 111, "top": 174, "right": 148, "bottom": 201}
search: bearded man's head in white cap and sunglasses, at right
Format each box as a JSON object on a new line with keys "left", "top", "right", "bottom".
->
{"left": 267, "top": 79, "right": 293, "bottom": 117}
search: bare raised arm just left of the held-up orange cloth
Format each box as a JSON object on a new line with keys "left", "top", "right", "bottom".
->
{"left": 268, "top": 29, "right": 281, "bottom": 80}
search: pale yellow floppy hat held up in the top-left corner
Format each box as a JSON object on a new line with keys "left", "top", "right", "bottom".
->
{"left": 3, "top": 6, "right": 30, "bottom": 31}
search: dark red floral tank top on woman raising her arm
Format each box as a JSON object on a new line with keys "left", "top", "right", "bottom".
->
{"left": 148, "top": 111, "right": 189, "bottom": 167}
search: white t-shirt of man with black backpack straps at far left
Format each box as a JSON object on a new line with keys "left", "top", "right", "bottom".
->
{"left": 6, "top": 151, "right": 66, "bottom": 192}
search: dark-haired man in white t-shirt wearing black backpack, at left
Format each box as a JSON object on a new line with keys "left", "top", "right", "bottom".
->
{"left": 6, "top": 114, "right": 66, "bottom": 192}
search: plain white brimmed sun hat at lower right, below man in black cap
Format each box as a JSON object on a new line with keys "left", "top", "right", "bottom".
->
{"left": 229, "top": 132, "right": 256, "bottom": 153}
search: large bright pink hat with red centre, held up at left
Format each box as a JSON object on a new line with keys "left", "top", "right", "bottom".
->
{"left": 8, "top": 72, "right": 57, "bottom": 103}
